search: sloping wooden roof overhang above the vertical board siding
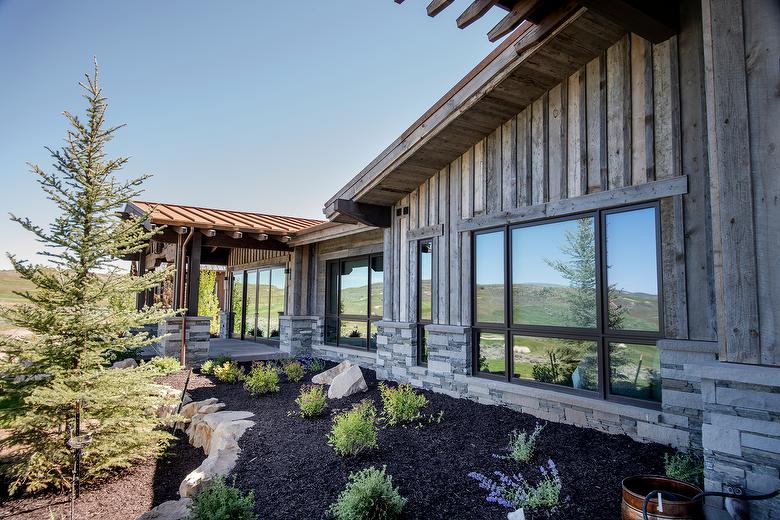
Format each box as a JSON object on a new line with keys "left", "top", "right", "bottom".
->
{"left": 323, "top": 1, "right": 660, "bottom": 217}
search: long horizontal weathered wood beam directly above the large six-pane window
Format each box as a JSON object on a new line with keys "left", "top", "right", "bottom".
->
{"left": 457, "top": 176, "right": 688, "bottom": 231}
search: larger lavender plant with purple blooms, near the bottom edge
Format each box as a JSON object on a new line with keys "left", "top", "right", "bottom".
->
{"left": 469, "top": 459, "right": 562, "bottom": 510}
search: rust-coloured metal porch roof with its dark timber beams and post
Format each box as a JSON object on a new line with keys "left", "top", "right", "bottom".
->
{"left": 123, "top": 201, "right": 323, "bottom": 316}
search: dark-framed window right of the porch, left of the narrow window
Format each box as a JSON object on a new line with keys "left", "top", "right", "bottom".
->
{"left": 325, "top": 254, "right": 384, "bottom": 350}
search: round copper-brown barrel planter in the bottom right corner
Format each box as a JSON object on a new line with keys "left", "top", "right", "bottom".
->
{"left": 620, "top": 475, "right": 704, "bottom": 520}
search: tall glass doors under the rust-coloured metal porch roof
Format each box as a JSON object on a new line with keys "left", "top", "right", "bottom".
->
{"left": 231, "top": 267, "right": 287, "bottom": 341}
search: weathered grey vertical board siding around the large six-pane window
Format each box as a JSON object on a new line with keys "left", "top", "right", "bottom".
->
{"left": 384, "top": 30, "right": 715, "bottom": 339}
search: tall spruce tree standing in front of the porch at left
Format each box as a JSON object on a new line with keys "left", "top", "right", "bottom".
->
{"left": 0, "top": 63, "right": 177, "bottom": 492}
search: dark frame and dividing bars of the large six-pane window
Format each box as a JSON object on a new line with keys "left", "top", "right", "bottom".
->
{"left": 471, "top": 200, "right": 664, "bottom": 409}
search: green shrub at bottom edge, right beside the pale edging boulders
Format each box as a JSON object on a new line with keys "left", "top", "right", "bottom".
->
{"left": 187, "top": 477, "right": 257, "bottom": 520}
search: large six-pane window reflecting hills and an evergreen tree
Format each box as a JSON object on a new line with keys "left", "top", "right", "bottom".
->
{"left": 473, "top": 203, "right": 662, "bottom": 406}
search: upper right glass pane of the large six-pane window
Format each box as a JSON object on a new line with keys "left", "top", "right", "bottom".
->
{"left": 606, "top": 208, "right": 658, "bottom": 331}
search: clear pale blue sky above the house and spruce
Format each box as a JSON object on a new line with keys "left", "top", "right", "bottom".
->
{"left": 0, "top": 0, "right": 501, "bottom": 269}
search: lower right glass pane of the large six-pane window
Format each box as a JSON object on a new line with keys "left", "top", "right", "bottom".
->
{"left": 609, "top": 343, "right": 661, "bottom": 402}
